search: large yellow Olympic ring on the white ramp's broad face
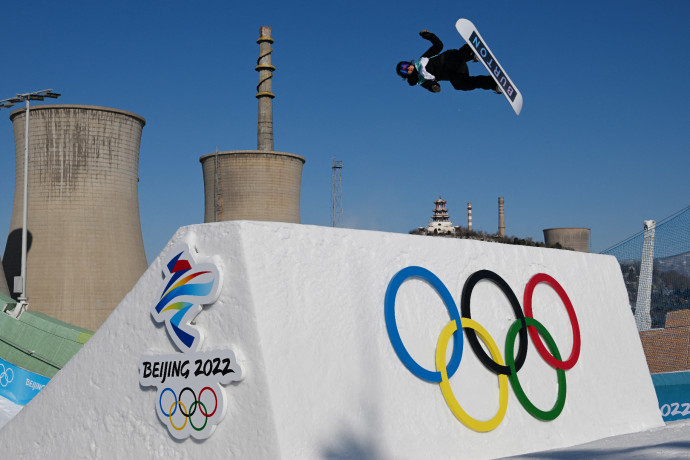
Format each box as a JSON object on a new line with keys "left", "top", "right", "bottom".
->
{"left": 436, "top": 318, "right": 508, "bottom": 432}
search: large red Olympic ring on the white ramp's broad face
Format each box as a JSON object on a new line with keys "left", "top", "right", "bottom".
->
{"left": 524, "top": 273, "right": 580, "bottom": 370}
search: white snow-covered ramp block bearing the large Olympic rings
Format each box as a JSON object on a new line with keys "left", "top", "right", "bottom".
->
{"left": 0, "top": 221, "right": 663, "bottom": 459}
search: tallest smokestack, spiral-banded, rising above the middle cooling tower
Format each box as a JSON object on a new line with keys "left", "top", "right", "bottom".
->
{"left": 256, "top": 27, "right": 276, "bottom": 152}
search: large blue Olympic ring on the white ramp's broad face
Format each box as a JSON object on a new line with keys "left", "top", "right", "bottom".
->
{"left": 384, "top": 265, "right": 463, "bottom": 383}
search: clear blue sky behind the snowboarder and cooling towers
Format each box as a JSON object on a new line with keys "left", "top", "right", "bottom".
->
{"left": 0, "top": 0, "right": 690, "bottom": 261}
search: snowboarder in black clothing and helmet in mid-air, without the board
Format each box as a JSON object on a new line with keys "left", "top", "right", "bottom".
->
{"left": 395, "top": 30, "right": 501, "bottom": 94}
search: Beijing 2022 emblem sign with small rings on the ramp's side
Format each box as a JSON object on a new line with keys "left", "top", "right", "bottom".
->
{"left": 139, "top": 244, "right": 242, "bottom": 440}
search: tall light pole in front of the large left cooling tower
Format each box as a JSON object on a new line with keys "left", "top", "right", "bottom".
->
{"left": 0, "top": 89, "right": 60, "bottom": 317}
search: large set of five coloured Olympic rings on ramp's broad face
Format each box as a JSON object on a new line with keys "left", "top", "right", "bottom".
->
{"left": 384, "top": 266, "right": 580, "bottom": 432}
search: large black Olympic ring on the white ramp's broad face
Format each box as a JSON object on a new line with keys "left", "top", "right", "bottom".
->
{"left": 460, "top": 270, "right": 527, "bottom": 375}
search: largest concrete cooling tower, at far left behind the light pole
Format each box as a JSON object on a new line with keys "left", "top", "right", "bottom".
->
{"left": 3, "top": 105, "right": 147, "bottom": 330}
